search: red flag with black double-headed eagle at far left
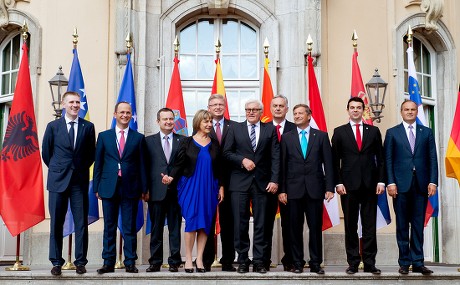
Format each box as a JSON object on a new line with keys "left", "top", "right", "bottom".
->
{"left": 0, "top": 41, "right": 45, "bottom": 236}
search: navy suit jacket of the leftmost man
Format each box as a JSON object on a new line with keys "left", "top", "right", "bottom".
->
{"left": 42, "top": 117, "right": 96, "bottom": 192}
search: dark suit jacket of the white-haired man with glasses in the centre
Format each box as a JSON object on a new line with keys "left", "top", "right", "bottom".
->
{"left": 223, "top": 121, "right": 280, "bottom": 192}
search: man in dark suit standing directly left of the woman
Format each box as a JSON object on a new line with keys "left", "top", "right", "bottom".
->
{"left": 145, "top": 108, "right": 183, "bottom": 272}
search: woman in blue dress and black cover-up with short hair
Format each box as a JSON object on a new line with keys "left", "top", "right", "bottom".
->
{"left": 163, "top": 110, "right": 224, "bottom": 273}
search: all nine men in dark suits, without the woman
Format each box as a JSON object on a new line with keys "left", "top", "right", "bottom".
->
{"left": 42, "top": 89, "right": 438, "bottom": 275}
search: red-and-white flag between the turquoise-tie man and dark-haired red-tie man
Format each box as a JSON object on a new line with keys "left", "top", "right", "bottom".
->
{"left": 308, "top": 54, "right": 340, "bottom": 231}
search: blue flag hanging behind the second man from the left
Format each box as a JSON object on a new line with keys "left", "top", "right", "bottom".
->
{"left": 112, "top": 52, "right": 144, "bottom": 235}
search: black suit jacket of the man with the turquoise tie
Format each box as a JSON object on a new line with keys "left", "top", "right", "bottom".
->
{"left": 280, "top": 128, "right": 335, "bottom": 199}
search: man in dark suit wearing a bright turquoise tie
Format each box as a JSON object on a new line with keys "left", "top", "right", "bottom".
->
{"left": 279, "top": 104, "right": 334, "bottom": 274}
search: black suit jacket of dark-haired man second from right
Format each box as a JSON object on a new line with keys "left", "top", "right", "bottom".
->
{"left": 332, "top": 123, "right": 385, "bottom": 191}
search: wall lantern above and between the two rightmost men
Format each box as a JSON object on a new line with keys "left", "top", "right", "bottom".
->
{"left": 366, "top": 68, "right": 388, "bottom": 123}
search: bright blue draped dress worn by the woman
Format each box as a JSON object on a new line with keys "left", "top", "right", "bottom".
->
{"left": 177, "top": 140, "right": 219, "bottom": 235}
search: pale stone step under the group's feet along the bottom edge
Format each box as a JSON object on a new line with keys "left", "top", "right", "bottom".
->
{"left": 0, "top": 265, "right": 460, "bottom": 285}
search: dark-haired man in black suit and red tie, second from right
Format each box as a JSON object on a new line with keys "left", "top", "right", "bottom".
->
{"left": 332, "top": 97, "right": 385, "bottom": 274}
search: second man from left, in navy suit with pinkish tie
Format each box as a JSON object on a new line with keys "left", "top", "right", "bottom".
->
{"left": 93, "top": 102, "right": 147, "bottom": 274}
